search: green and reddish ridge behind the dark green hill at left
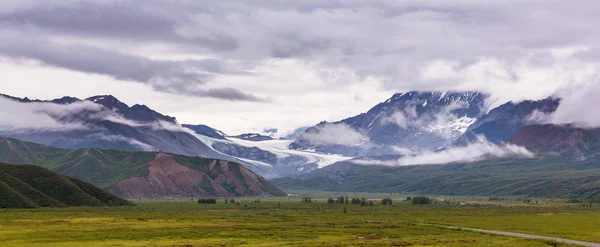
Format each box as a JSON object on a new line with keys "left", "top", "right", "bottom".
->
{"left": 0, "top": 138, "right": 285, "bottom": 198}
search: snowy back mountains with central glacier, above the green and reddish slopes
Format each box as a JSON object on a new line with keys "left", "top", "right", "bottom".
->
{"left": 0, "top": 92, "right": 559, "bottom": 178}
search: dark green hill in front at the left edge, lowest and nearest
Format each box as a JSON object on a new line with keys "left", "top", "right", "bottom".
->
{"left": 0, "top": 163, "right": 134, "bottom": 208}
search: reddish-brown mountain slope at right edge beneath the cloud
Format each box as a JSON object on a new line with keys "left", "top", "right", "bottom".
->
{"left": 509, "top": 124, "right": 600, "bottom": 152}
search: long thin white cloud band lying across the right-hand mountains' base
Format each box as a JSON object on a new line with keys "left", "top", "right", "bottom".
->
{"left": 353, "top": 137, "right": 534, "bottom": 166}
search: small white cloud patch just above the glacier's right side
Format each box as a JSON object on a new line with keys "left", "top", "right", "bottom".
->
{"left": 301, "top": 123, "right": 370, "bottom": 146}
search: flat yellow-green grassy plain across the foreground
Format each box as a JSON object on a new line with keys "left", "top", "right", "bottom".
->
{"left": 0, "top": 196, "right": 600, "bottom": 246}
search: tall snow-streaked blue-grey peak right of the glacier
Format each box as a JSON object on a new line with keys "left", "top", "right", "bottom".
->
{"left": 290, "top": 92, "right": 487, "bottom": 157}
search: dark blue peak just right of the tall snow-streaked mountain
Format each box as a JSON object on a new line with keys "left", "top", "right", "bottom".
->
{"left": 458, "top": 98, "right": 560, "bottom": 143}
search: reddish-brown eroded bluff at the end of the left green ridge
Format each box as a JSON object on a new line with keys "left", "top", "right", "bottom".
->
{"left": 106, "top": 153, "right": 279, "bottom": 198}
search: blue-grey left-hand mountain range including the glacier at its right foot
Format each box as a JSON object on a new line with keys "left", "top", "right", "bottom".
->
{"left": 0, "top": 95, "right": 344, "bottom": 178}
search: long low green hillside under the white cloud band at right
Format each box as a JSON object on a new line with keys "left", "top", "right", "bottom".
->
{"left": 272, "top": 149, "right": 600, "bottom": 198}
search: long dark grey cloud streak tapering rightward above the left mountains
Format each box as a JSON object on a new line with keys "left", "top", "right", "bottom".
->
{"left": 0, "top": 29, "right": 266, "bottom": 102}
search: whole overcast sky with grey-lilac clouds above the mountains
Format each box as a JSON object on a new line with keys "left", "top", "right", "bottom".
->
{"left": 0, "top": 0, "right": 600, "bottom": 134}
